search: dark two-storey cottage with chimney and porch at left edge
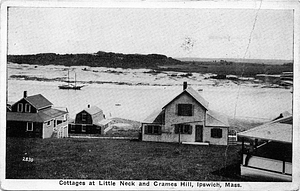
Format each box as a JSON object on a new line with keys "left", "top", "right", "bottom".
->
{"left": 7, "top": 91, "right": 68, "bottom": 138}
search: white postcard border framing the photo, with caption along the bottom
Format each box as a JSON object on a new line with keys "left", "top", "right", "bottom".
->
{"left": 0, "top": 0, "right": 300, "bottom": 190}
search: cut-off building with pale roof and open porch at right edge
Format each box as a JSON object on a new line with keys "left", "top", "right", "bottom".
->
{"left": 238, "top": 114, "right": 293, "bottom": 181}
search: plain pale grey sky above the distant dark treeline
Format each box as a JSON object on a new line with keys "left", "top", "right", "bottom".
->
{"left": 8, "top": 7, "right": 293, "bottom": 60}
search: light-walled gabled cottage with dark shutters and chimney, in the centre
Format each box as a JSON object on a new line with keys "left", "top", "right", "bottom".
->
{"left": 142, "top": 82, "right": 229, "bottom": 145}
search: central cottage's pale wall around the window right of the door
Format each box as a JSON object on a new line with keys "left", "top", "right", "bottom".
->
{"left": 203, "top": 127, "right": 228, "bottom": 145}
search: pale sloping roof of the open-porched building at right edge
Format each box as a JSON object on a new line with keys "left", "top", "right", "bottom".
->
{"left": 238, "top": 116, "right": 293, "bottom": 143}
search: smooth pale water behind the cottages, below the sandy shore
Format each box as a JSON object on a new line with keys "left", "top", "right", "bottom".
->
{"left": 8, "top": 80, "right": 292, "bottom": 121}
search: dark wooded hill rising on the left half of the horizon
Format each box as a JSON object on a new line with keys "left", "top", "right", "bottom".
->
{"left": 7, "top": 51, "right": 181, "bottom": 68}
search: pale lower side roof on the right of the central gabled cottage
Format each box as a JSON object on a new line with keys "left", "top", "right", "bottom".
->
{"left": 206, "top": 110, "right": 229, "bottom": 127}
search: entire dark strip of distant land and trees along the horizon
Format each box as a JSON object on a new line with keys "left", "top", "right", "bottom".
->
{"left": 7, "top": 51, "right": 293, "bottom": 77}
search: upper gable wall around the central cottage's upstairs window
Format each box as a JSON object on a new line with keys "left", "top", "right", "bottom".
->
{"left": 165, "top": 94, "right": 206, "bottom": 131}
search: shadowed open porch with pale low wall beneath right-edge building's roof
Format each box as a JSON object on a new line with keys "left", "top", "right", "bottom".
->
{"left": 241, "top": 141, "right": 292, "bottom": 181}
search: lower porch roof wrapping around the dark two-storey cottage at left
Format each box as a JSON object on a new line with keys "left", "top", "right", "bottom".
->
{"left": 7, "top": 108, "right": 67, "bottom": 122}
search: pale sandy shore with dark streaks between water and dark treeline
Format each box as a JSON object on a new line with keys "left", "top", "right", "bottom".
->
{"left": 8, "top": 63, "right": 290, "bottom": 89}
